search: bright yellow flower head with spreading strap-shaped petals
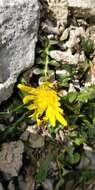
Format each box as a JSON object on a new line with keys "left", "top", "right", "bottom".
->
{"left": 18, "top": 82, "right": 67, "bottom": 126}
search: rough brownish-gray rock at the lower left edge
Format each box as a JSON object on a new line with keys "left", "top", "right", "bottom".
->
{"left": 0, "top": 141, "right": 24, "bottom": 179}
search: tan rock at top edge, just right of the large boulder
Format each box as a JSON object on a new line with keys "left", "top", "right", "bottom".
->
{"left": 42, "top": 0, "right": 68, "bottom": 34}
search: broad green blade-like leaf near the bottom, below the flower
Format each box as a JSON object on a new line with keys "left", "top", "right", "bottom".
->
{"left": 36, "top": 154, "right": 52, "bottom": 183}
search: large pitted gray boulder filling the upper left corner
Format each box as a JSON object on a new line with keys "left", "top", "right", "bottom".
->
{"left": 0, "top": 0, "right": 39, "bottom": 103}
